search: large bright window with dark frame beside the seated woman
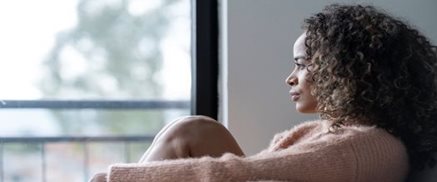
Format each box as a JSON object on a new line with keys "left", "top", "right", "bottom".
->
{"left": 0, "top": 0, "right": 217, "bottom": 181}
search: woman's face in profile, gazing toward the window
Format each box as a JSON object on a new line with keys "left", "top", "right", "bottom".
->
{"left": 285, "top": 33, "right": 317, "bottom": 113}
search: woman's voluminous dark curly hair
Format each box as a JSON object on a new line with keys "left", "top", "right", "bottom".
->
{"left": 304, "top": 4, "right": 437, "bottom": 170}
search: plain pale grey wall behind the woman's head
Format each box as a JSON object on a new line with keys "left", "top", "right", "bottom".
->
{"left": 220, "top": 0, "right": 437, "bottom": 154}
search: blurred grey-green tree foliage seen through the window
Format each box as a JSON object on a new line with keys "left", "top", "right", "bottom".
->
{"left": 40, "top": 0, "right": 178, "bottom": 135}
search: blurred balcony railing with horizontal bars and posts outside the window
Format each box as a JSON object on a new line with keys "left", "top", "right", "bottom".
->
{"left": 0, "top": 100, "right": 190, "bottom": 182}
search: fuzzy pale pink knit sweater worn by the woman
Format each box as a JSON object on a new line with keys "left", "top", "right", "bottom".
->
{"left": 108, "top": 121, "right": 408, "bottom": 182}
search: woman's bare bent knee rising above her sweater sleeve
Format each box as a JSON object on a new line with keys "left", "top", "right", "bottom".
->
{"left": 140, "top": 116, "right": 244, "bottom": 162}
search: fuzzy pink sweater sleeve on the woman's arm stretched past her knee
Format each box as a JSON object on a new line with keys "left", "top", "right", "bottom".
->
{"left": 108, "top": 136, "right": 355, "bottom": 182}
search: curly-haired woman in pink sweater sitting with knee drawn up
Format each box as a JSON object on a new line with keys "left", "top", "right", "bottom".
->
{"left": 90, "top": 5, "right": 437, "bottom": 182}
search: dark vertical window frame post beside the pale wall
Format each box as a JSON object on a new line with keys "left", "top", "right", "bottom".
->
{"left": 191, "top": 0, "right": 218, "bottom": 119}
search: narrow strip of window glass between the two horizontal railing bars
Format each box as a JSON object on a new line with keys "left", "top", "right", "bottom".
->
{"left": 0, "top": 108, "right": 189, "bottom": 137}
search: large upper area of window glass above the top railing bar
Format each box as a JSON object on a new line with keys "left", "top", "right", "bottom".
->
{"left": 0, "top": 0, "right": 191, "bottom": 100}
